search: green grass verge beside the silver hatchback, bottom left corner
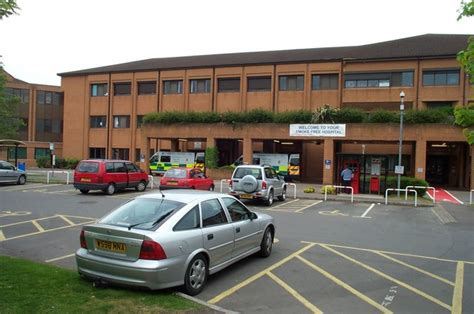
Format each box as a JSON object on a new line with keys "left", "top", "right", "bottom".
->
{"left": 0, "top": 256, "right": 202, "bottom": 313}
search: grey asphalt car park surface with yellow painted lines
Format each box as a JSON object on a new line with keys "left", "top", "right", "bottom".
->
{"left": 0, "top": 183, "right": 474, "bottom": 313}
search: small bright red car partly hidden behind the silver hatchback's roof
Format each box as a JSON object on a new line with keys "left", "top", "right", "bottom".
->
{"left": 160, "top": 168, "right": 214, "bottom": 191}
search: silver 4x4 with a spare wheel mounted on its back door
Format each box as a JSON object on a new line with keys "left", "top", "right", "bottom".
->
{"left": 229, "top": 165, "right": 287, "bottom": 206}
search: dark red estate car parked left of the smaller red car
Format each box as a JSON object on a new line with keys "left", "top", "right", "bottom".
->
{"left": 74, "top": 159, "right": 148, "bottom": 195}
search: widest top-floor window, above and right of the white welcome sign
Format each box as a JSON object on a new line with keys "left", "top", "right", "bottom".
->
{"left": 344, "top": 71, "right": 413, "bottom": 88}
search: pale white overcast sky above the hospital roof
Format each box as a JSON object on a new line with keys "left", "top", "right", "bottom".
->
{"left": 0, "top": 0, "right": 474, "bottom": 85}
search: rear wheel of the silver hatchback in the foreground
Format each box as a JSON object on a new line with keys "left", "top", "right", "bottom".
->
{"left": 184, "top": 254, "right": 209, "bottom": 295}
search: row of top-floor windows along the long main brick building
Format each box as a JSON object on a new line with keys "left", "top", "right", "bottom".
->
{"left": 91, "top": 70, "right": 460, "bottom": 96}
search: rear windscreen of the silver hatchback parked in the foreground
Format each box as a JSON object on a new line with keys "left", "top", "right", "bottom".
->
{"left": 99, "top": 198, "right": 186, "bottom": 230}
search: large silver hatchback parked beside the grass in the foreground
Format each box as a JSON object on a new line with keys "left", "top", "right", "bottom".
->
{"left": 76, "top": 190, "right": 275, "bottom": 295}
